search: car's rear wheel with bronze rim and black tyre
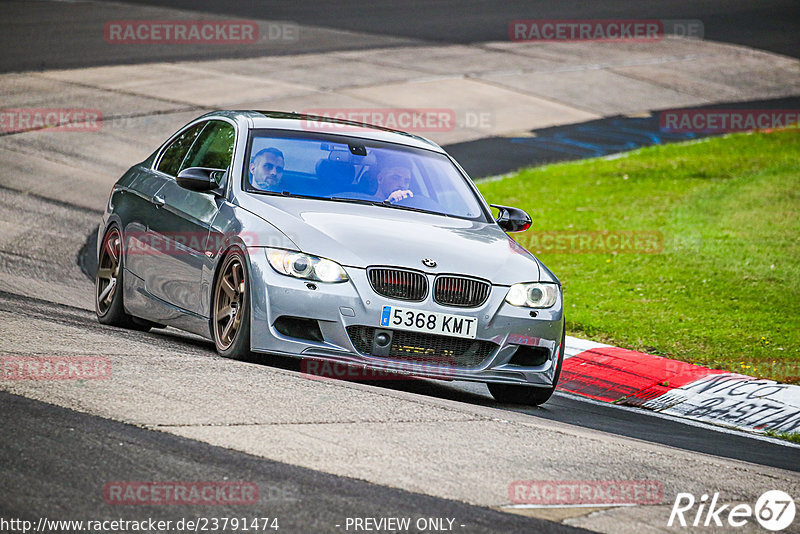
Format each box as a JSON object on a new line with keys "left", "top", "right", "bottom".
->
{"left": 94, "top": 226, "right": 151, "bottom": 332}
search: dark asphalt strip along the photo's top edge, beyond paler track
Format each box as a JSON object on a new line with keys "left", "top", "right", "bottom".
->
{"left": 0, "top": 0, "right": 800, "bottom": 72}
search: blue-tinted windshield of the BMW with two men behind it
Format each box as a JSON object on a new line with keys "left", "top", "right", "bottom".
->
{"left": 245, "top": 130, "right": 485, "bottom": 220}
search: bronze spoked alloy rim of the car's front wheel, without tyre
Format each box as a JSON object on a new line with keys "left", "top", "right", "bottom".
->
{"left": 214, "top": 253, "right": 247, "bottom": 352}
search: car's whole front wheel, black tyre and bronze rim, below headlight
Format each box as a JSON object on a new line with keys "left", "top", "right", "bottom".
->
{"left": 211, "top": 250, "right": 253, "bottom": 361}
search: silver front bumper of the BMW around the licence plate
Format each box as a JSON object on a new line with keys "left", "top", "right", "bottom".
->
{"left": 248, "top": 247, "right": 564, "bottom": 387}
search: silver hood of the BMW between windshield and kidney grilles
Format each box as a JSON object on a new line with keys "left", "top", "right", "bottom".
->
{"left": 234, "top": 195, "right": 540, "bottom": 285}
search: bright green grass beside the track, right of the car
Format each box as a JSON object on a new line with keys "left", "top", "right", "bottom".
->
{"left": 479, "top": 130, "right": 800, "bottom": 382}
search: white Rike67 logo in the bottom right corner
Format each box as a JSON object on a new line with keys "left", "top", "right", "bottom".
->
{"left": 667, "top": 490, "right": 796, "bottom": 532}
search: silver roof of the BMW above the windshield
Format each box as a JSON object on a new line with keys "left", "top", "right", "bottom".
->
{"left": 197, "top": 110, "right": 444, "bottom": 153}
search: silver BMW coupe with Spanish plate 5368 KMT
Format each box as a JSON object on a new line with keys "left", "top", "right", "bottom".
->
{"left": 95, "top": 111, "right": 564, "bottom": 405}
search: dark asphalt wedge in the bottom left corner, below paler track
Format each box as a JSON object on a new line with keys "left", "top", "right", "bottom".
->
{"left": 0, "top": 392, "right": 587, "bottom": 534}
